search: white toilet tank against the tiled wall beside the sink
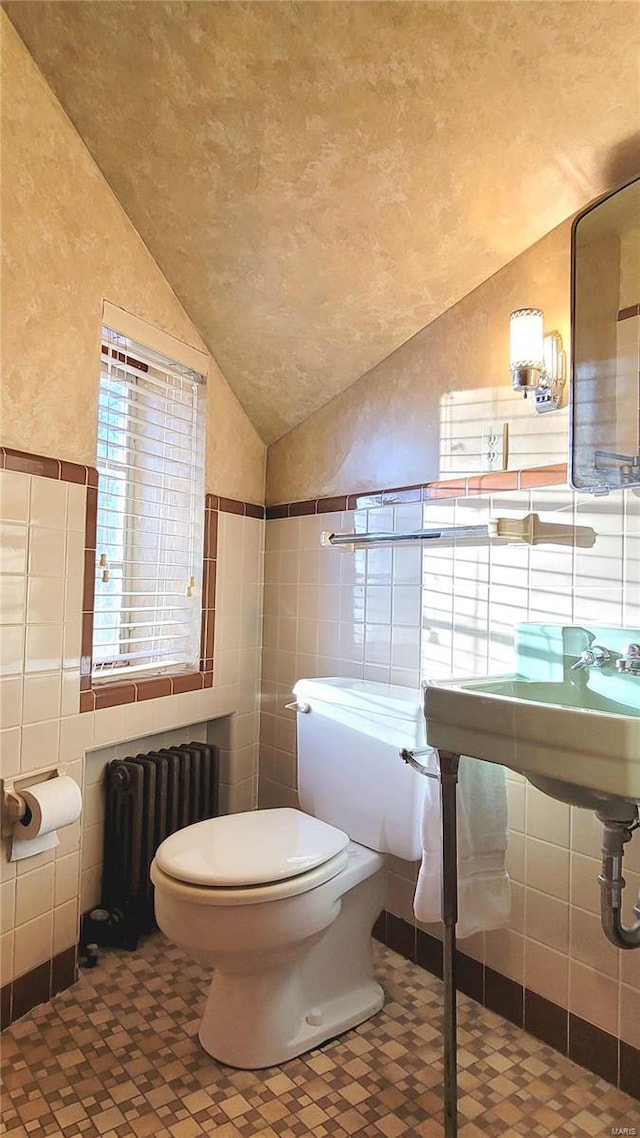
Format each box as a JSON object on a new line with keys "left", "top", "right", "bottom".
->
{"left": 294, "top": 678, "right": 430, "bottom": 861}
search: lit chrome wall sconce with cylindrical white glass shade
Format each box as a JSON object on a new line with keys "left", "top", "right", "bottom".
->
{"left": 509, "top": 308, "right": 565, "bottom": 413}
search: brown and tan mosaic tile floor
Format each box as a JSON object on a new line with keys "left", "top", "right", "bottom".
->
{"left": 1, "top": 933, "right": 640, "bottom": 1138}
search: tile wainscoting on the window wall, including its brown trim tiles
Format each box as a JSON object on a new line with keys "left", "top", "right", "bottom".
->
{"left": 0, "top": 448, "right": 264, "bottom": 1023}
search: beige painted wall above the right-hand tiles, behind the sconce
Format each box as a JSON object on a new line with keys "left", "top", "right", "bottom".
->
{"left": 266, "top": 221, "right": 571, "bottom": 503}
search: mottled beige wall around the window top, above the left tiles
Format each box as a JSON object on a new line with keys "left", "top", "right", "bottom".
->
{"left": 0, "top": 14, "right": 265, "bottom": 502}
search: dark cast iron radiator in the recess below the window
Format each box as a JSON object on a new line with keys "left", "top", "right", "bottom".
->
{"left": 97, "top": 743, "right": 219, "bottom": 948}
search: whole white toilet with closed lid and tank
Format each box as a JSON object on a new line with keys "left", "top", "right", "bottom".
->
{"left": 150, "top": 678, "right": 427, "bottom": 1070}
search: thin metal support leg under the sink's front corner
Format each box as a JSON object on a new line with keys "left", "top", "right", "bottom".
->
{"left": 438, "top": 751, "right": 460, "bottom": 1138}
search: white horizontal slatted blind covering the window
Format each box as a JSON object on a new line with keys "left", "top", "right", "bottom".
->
{"left": 93, "top": 328, "right": 206, "bottom": 681}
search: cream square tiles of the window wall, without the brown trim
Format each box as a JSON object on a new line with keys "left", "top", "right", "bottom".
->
{"left": 0, "top": 471, "right": 264, "bottom": 983}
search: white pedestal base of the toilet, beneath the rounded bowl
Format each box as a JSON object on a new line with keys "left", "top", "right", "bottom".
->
{"left": 198, "top": 843, "right": 385, "bottom": 1070}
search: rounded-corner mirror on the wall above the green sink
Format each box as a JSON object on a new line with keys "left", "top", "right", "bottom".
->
{"left": 569, "top": 179, "right": 640, "bottom": 494}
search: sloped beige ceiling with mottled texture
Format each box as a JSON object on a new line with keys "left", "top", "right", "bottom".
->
{"left": 5, "top": 0, "right": 640, "bottom": 442}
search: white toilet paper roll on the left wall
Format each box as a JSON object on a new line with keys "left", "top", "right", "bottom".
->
{"left": 11, "top": 775, "right": 82, "bottom": 861}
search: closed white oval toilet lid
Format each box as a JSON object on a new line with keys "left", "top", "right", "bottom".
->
{"left": 156, "top": 808, "right": 348, "bottom": 887}
